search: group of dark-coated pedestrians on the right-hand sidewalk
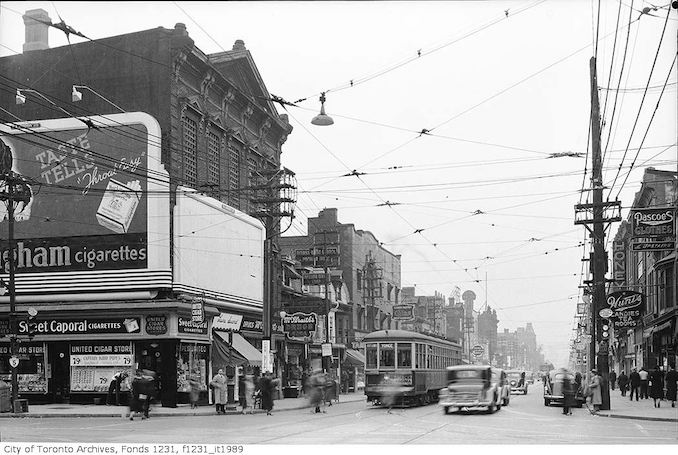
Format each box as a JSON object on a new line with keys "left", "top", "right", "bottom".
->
{"left": 610, "top": 365, "right": 678, "bottom": 408}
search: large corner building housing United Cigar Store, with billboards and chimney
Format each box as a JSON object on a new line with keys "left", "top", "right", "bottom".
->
{"left": 0, "top": 10, "right": 292, "bottom": 407}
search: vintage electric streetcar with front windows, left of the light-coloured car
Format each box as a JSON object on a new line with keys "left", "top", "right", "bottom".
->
{"left": 363, "top": 330, "right": 461, "bottom": 406}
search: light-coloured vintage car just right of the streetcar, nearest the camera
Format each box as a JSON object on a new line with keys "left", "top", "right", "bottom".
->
{"left": 438, "top": 365, "right": 506, "bottom": 414}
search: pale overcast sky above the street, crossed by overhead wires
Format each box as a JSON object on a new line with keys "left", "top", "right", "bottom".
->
{"left": 0, "top": 0, "right": 678, "bottom": 366}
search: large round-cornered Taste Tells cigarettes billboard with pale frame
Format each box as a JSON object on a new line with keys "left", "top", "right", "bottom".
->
{"left": 0, "top": 113, "right": 169, "bottom": 292}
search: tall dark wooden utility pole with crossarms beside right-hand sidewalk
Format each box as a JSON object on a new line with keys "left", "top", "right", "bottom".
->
{"left": 575, "top": 57, "right": 621, "bottom": 410}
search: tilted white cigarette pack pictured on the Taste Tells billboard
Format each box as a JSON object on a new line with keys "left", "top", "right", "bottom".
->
{"left": 97, "top": 179, "right": 141, "bottom": 234}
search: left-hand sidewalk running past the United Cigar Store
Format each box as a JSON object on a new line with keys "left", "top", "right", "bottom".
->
{"left": 0, "top": 391, "right": 366, "bottom": 418}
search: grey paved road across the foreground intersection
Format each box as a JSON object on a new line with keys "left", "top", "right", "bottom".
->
{"left": 0, "top": 393, "right": 678, "bottom": 450}
